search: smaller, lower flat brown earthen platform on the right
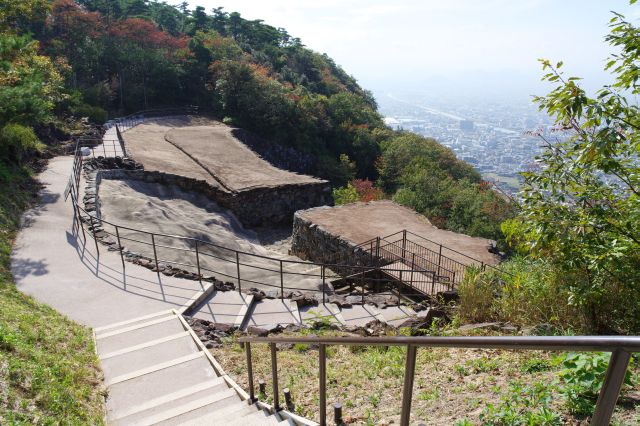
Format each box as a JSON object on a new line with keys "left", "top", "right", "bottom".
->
{"left": 293, "top": 200, "right": 499, "bottom": 265}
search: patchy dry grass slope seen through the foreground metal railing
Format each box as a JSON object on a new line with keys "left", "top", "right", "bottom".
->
{"left": 211, "top": 330, "right": 640, "bottom": 426}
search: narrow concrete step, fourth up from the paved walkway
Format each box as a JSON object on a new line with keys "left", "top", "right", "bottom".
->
{"left": 113, "top": 377, "right": 229, "bottom": 425}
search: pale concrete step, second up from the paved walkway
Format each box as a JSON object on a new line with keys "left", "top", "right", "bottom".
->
{"left": 101, "top": 331, "right": 199, "bottom": 383}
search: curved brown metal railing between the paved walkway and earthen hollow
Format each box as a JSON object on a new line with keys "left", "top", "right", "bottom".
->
{"left": 68, "top": 139, "right": 444, "bottom": 303}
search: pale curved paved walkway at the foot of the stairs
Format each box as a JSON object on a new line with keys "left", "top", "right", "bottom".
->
{"left": 11, "top": 156, "right": 200, "bottom": 327}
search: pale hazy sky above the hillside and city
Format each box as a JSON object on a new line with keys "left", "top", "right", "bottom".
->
{"left": 172, "top": 0, "right": 640, "bottom": 100}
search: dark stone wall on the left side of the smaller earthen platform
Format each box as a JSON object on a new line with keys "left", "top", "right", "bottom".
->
{"left": 291, "top": 213, "right": 376, "bottom": 275}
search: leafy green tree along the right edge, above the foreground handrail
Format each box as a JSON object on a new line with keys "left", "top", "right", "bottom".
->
{"left": 509, "top": 1, "right": 640, "bottom": 332}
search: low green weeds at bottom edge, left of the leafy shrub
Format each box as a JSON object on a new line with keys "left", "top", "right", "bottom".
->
{"left": 480, "top": 382, "right": 563, "bottom": 426}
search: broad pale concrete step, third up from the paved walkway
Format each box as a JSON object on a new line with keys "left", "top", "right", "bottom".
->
{"left": 107, "top": 356, "right": 217, "bottom": 419}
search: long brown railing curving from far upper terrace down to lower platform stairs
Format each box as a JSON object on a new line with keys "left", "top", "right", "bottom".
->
{"left": 65, "top": 109, "right": 464, "bottom": 303}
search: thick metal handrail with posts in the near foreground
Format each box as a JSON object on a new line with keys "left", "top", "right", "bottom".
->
{"left": 238, "top": 336, "right": 640, "bottom": 426}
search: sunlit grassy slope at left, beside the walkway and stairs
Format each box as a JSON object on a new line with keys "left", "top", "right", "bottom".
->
{"left": 0, "top": 163, "right": 103, "bottom": 424}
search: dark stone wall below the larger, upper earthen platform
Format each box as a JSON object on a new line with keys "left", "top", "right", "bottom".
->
{"left": 98, "top": 169, "right": 333, "bottom": 226}
